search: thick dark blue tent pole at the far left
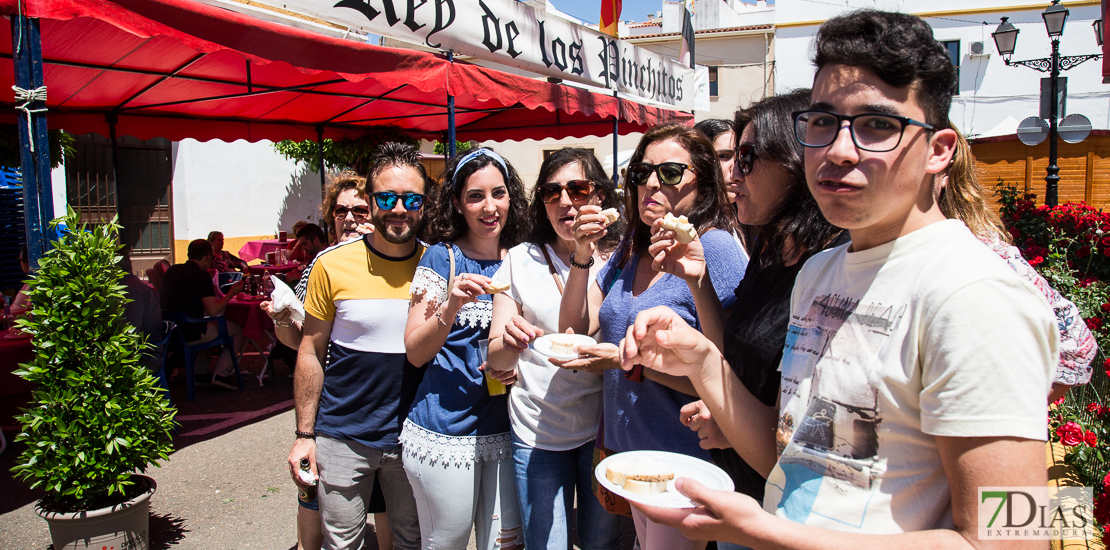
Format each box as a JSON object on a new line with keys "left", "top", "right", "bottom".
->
{"left": 11, "top": 14, "right": 54, "bottom": 268}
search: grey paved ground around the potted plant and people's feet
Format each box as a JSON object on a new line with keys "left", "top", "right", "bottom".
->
{"left": 0, "top": 354, "right": 633, "bottom": 550}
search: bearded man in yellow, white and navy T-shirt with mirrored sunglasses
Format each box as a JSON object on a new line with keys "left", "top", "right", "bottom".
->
{"left": 289, "top": 143, "right": 432, "bottom": 550}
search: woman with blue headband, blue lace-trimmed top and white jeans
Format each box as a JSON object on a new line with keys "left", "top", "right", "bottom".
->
{"left": 401, "top": 148, "right": 528, "bottom": 550}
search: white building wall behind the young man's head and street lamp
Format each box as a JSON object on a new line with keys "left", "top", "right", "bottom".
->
{"left": 776, "top": 0, "right": 1110, "bottom": 137}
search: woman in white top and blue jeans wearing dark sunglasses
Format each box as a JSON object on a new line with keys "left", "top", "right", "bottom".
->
{"left": 488, "top": 148, "right": 620, "bottom": 550}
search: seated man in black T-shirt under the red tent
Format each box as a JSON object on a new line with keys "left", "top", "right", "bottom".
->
{"left": 160, "top": 236, "right": 243, "bottom": 390}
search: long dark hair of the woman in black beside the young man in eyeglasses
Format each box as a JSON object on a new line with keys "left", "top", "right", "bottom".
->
{"left": 735, "top": 89, "right": 840, "bottom": 267}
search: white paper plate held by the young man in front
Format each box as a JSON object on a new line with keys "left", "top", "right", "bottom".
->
{"left": 594, "top": 451, "right": 736, "bottom": 508}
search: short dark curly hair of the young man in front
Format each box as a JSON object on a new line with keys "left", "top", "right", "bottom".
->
{"left": 814, "top": 9, "right": 956, "bottom": 129}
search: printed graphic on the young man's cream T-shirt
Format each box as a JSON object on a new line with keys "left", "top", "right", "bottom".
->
{"left": 771, "top": 294, "right": 907, "bottom": 526}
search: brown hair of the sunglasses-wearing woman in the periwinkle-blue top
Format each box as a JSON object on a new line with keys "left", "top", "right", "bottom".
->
{"left": 620, "top": 122, "right": 736, "bottom": 266}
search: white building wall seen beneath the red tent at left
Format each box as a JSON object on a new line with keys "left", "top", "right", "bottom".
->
{"left": 173, "top": 139, "right": 320, "bottom": 244}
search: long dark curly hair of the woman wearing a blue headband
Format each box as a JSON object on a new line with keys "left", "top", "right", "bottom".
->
{"left": 424, "top": 147, "right": 529, "bottom": 248}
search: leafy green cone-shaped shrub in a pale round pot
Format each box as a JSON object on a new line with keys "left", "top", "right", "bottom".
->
{"left": 12, "top": 209, "right": 174, "bottom": 550}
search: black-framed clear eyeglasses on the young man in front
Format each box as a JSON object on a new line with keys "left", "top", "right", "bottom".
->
{"left": 794, "top": 109, "right": 936, "bottom": 152}
